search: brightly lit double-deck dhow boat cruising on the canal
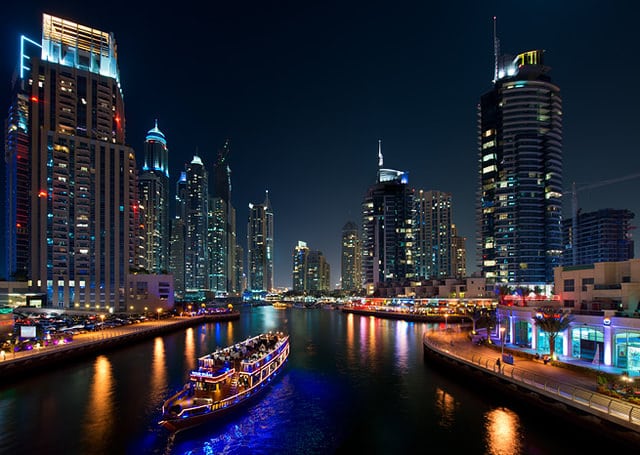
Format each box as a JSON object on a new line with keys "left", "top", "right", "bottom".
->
{"left": 159, "top": 332, "right": 289, "bottom": 432}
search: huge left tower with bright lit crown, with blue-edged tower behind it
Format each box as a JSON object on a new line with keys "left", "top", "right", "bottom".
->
{"left": 5, "top": 14, "right": 138, "bottom": 310}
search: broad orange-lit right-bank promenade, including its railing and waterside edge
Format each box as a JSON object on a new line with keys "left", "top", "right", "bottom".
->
{"left": 423, "top": 327, "right": 640, "bottom": 443}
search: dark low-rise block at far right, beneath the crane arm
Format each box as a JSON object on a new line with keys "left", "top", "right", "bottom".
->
{"left": 562, "top": 209, "right": 635, "bottom": 265}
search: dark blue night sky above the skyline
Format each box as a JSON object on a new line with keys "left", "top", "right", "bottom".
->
{"left": 0, "top": 0, "right": 640, "bottom": 287}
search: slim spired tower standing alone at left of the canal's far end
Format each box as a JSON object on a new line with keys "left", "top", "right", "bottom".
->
{"left": 247, "top": 191, "right": 274, "bottom": 292}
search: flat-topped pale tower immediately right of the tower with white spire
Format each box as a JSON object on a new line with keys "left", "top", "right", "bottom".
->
{"left": 413, "top": 190, "right": 454, "bottom": 279}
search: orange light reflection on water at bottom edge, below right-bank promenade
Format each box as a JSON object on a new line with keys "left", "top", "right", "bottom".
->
{"left": 485, "top": 408, "right": 522, "bottom": 455}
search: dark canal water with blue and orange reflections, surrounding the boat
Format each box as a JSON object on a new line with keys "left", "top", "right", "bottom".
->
{"left": 0, "top": 307, "right": 622, "bottom": 455}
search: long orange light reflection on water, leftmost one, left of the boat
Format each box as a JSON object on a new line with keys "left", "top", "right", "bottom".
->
{"left": 79, "top": 355, "right": 115, "bottom": 449}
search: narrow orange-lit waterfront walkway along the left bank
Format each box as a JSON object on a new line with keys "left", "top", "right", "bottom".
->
{"left": 0, "top": 311, "right": 240, "bottom": 383}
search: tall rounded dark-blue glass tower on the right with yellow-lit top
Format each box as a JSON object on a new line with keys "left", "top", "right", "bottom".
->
{"left": 477, "top": 50, "right": 562, "bottom": 284}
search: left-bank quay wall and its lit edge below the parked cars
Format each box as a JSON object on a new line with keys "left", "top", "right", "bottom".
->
{"left": 0, "top": 311, "right": 240, "bottom": 385}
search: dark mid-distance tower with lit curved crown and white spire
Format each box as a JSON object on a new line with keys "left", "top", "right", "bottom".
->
{"left": 362, "top": 142, "right": 415, "bottom": 291}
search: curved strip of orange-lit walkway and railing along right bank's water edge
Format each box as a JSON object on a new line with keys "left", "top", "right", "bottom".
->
{"left": 423, "top": 333, "right": 640, "bottom": 431}
